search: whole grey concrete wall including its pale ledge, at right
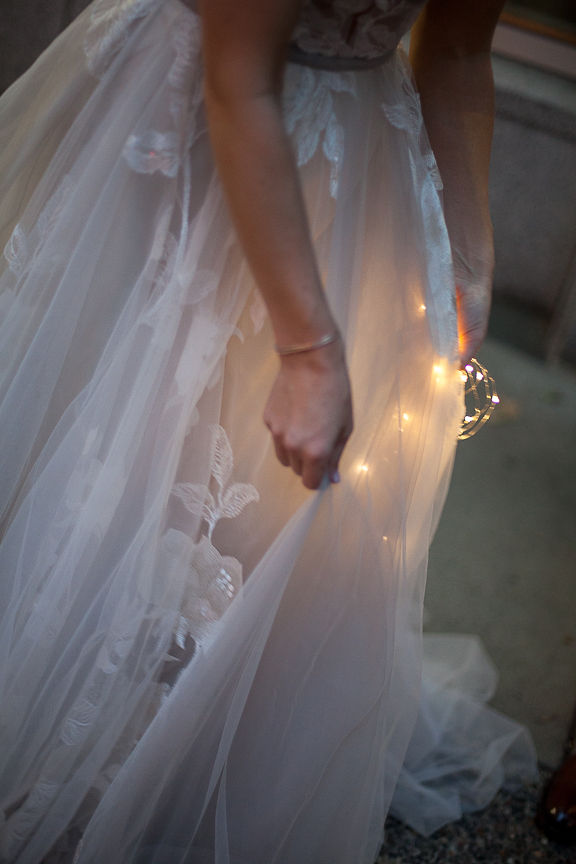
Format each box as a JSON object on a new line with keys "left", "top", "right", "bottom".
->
{"left": 491, "top": 58, "right": 576, "bottom": 355}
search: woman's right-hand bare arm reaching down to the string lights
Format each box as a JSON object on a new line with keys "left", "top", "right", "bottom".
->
{"left": 410, "top": 0, "right": 503, "bottom": 362}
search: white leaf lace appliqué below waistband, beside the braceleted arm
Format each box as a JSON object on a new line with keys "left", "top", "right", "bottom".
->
{"left": 284, "top": 67, "right": 356, "bottom": 198}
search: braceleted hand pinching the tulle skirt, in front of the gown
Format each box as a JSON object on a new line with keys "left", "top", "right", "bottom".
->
{"left": 264, "top": 340, "right": 353, "bottom": 489}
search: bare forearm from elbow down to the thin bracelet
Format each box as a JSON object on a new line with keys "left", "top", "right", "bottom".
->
{"left": 206, "top": 91, "right": 335, "bottom": 344}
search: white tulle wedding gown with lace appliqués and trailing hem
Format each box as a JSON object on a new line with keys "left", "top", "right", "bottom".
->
{"left": 0, "top": 0, "right": 534, "bottom": 864}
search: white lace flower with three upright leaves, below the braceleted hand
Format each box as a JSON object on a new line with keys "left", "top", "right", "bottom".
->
{"left": 172, "top": 426, "right": 260, "bottom": 648}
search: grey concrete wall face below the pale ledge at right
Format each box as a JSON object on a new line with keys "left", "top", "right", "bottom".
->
{"left": 491, "top": 91, "right": 576, "bottom": 308}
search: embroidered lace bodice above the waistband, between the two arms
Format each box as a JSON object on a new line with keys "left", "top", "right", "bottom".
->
{"left": 292, "top": 0, "right": 425, "bottom": 60}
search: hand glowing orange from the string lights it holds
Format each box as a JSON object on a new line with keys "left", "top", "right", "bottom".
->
{"left": 453, "top": 238, "right": 494, "bottom": 366}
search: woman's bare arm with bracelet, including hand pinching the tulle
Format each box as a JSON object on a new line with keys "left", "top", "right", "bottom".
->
{"left": 200, "top": 0, "right": 352, "bottom": 488}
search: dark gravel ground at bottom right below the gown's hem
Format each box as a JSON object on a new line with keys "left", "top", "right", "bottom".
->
{"left": 377, "top": 770, "right": 576, "bottom": 864}
